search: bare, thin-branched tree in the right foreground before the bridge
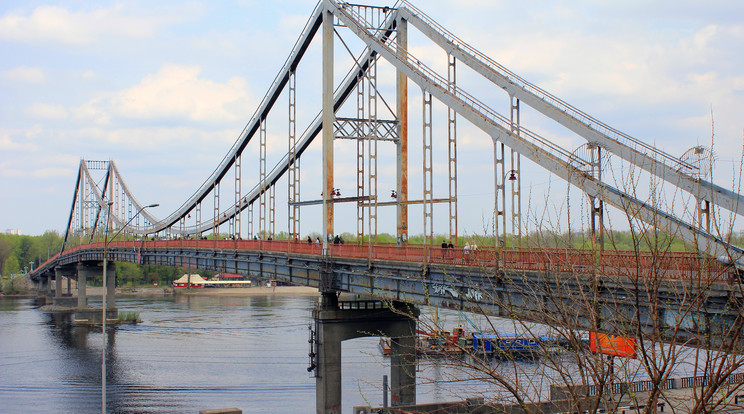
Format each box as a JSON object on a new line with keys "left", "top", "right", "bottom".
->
{"left": 372, "top": 159, "right": 744, "bottom": 413}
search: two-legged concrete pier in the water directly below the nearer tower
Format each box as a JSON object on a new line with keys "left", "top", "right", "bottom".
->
{"left": 313, "top": 293, "right": 419, "bottom": 414}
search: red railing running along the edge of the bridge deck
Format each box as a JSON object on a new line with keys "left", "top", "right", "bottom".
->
{"left": 39, "top": 239, "right": 738, "bottom": 281}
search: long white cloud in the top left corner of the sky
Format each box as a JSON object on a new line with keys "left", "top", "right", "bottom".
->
{"left": 0, "top": 4, "right": 198, "bottom": 45}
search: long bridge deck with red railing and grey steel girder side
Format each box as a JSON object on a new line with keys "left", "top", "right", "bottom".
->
{"left": 34, "top": 240, "right": 740, "bottom": 348}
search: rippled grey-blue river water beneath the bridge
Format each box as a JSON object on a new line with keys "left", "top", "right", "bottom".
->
{"left": 0, "top": 296, "right": 502, "bottom": 413}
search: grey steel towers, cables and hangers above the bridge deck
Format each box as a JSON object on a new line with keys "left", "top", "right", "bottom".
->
{"left": 66, "top": 0, "right": 744, "bottom": 259}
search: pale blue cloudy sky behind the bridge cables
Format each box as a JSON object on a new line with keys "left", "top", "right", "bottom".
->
{"left": 0, "top": 0, "right": 744, "bottom": 239}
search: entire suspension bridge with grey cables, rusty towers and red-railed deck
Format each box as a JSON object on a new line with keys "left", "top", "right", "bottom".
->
{"left": 26, "top": 0, "right": 744, "bottom": 412}
